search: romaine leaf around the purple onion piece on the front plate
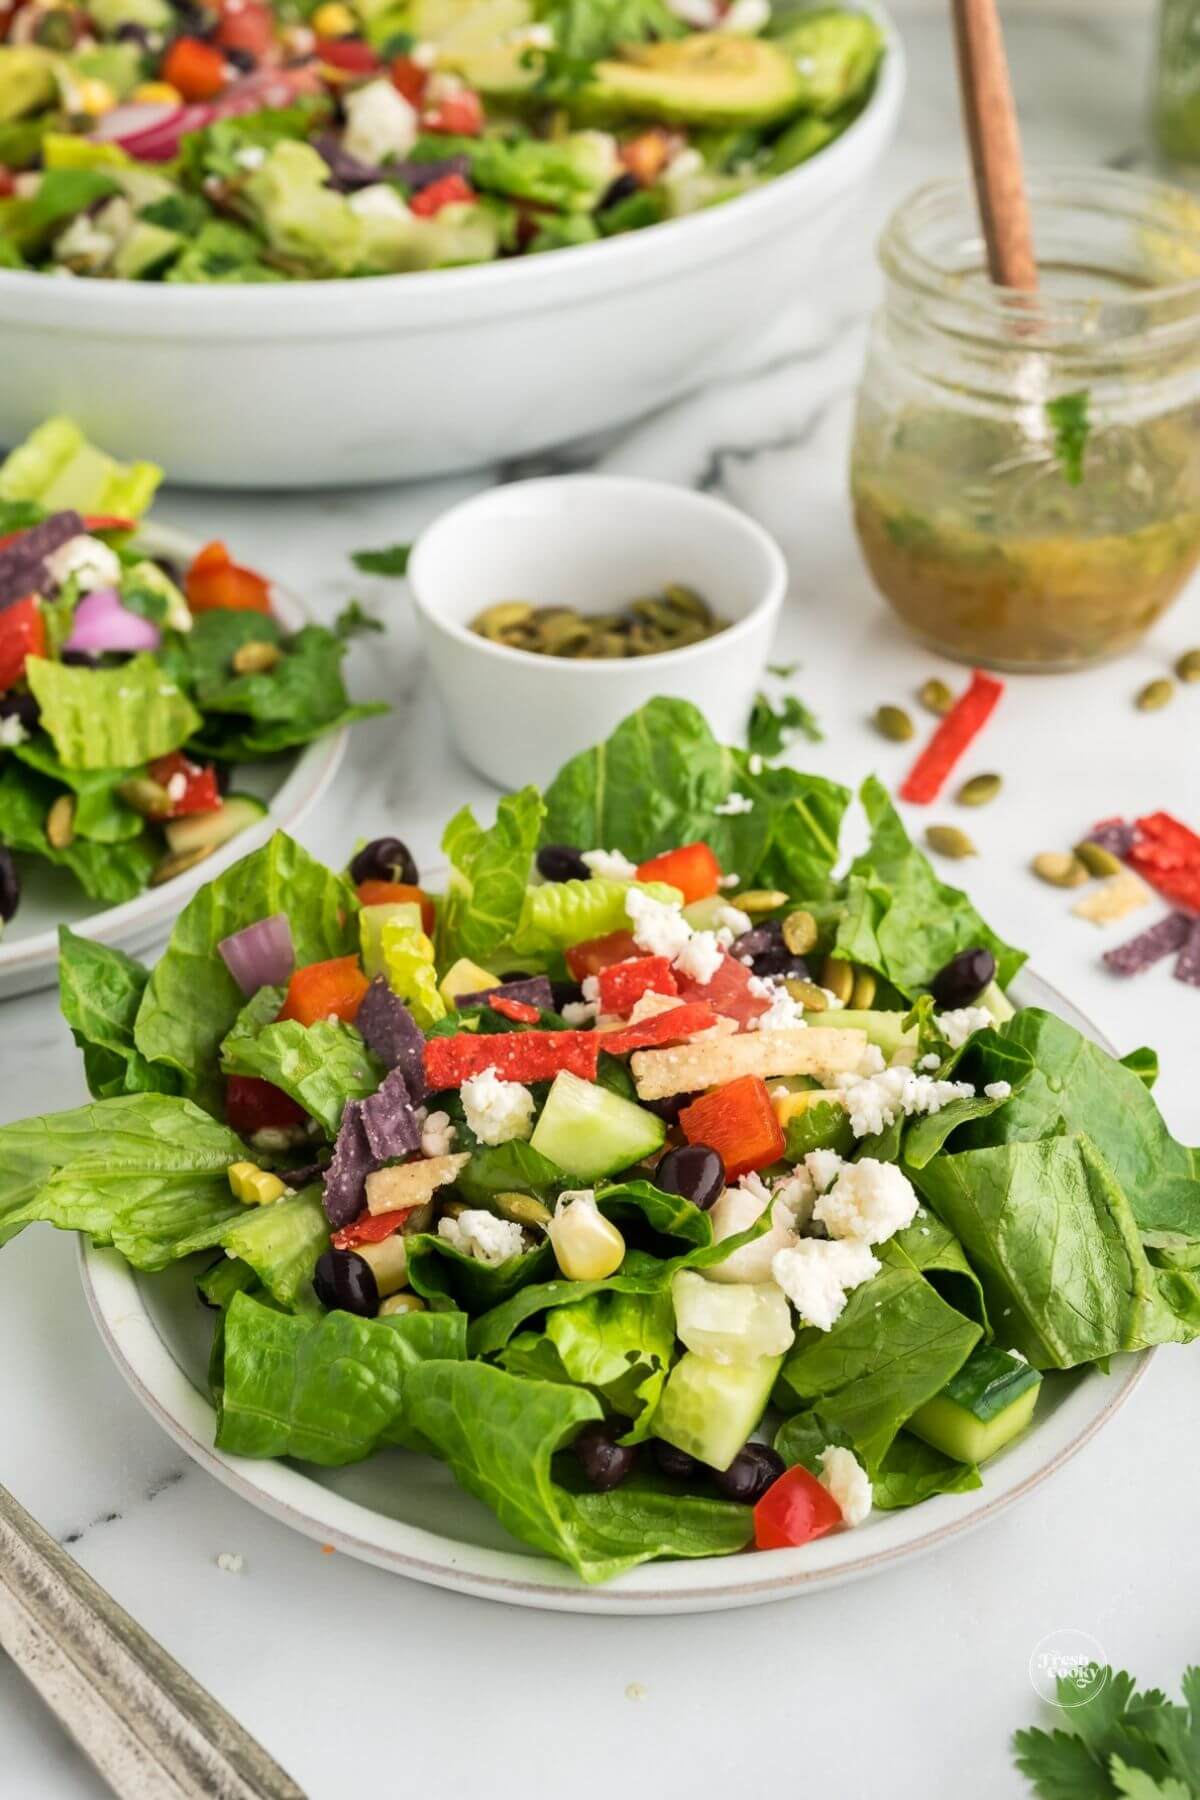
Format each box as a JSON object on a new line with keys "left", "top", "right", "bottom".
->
{"left": 133, "top": 832, "right": 358, "bottom": 1112}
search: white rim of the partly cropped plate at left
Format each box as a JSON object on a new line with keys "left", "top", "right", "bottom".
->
{"left": 0, "top": 524, "right": 347, "bottom": 997}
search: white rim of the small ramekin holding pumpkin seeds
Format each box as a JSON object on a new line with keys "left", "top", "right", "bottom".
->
{"left": 407, "top": 473, "right": 788, "bottom": 682}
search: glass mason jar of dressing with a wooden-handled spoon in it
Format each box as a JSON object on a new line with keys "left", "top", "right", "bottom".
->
{"left": 851, "top": 169, "right": 1200, "bottom": 670}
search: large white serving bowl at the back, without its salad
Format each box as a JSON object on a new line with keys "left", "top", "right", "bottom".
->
{"left": 0, "top": 7, "right": 905, "bottom": 488}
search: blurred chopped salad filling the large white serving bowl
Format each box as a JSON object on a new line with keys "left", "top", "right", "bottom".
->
{"left": 0, "top": 0, "right": 883, "bottom": 283}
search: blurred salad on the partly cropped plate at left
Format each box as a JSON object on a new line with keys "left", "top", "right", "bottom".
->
{"left": 0, "top": 419, "right": 380, "bottom": 931}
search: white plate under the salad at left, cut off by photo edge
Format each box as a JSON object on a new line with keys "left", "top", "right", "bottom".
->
{"left": 0, "top": 526, "right": 345, "bottom": 999}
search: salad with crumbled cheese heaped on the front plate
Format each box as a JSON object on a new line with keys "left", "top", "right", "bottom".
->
{"left": 0, "top": 700, "right": 1200, "bottom": 1582}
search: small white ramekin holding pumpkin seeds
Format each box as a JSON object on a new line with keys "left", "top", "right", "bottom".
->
{"left": 408, "top": 475, "right": 788, "bottom": 788}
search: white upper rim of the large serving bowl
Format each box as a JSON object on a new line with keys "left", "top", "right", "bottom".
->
{"left": 0, "top": 0, "right": 905, "bottom": 335}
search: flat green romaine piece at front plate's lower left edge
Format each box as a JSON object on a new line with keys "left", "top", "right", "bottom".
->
{"left": 216, "top": 1294, "right": 466, "bottom": 1469}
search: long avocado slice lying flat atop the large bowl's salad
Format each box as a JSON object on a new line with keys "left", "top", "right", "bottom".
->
{"left": 579, "top": 31, "right": 804, "bottom": 126}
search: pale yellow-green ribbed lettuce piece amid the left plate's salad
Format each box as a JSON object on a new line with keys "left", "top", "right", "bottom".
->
{"left": 25, "top": 655, "right": 200, "bottom": 770}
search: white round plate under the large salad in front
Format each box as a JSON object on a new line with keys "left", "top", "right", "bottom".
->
{"left": 79, "top": 972, "right": 1150, "bottom": 1615}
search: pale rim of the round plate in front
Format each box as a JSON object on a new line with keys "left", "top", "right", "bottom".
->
{"left": 79, "top": 970, "right": 1153, "bottom": 1616}
